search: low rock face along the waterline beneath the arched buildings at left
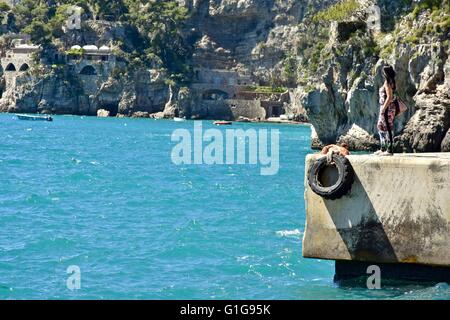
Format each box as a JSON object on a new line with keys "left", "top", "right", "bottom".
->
{"left": 0, "top": 70, "right": 168, "bottom": 116}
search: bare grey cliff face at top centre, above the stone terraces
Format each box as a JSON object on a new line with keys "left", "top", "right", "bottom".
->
{"left": 184, "top": 0, "right": 337, "bottom": 78}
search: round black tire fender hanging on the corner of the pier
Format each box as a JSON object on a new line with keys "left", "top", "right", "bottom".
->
{"left": 308, "top": 155, "right": 354, "bottom": 200}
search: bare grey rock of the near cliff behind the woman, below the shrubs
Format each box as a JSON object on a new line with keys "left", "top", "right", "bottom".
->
{"left": 298, "top": 1, "right": 450, "bottom": 152}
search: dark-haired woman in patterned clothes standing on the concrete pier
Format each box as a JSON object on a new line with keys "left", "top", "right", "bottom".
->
{"left": 375, "top": 66, "right": 397, "bottom": 155}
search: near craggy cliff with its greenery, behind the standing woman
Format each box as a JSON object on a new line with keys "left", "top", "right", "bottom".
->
{"left": 297, "top": 0, "right": 450, "bottom": 152}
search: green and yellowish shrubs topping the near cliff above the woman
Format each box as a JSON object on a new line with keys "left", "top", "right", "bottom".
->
{"left": 298, "top": 0, "right": 450, "bottom": 88}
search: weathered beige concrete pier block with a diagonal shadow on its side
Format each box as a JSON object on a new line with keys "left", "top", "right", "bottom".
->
{"left": 303, "top": 153, "right": 450, "bottom": 267}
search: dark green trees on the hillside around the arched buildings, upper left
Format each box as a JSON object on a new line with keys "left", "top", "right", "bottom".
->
{"left": 0, "top": 0, "right": 191, "bottom": 81}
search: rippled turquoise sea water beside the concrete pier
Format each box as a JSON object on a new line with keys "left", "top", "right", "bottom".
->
{"left": 0, "top": 114, "right": 450, "bottom": 299}
